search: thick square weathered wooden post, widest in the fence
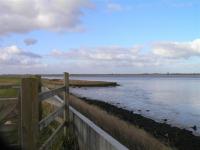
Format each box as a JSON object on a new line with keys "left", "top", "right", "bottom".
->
{"left": 21, "top": 78, "right": 39, "bottom": 150}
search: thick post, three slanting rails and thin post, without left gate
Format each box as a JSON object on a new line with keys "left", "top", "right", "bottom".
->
{"left": 21, "top": 73, "right": 69, "bottom": 150}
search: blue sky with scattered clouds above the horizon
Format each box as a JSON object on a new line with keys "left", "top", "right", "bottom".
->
{"left": 0, "top": 0, "right": 200, "bottom": 74}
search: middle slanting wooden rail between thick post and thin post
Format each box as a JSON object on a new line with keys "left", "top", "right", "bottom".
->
{"left": 39, "top": 105, "right": 64, "bottom": 130}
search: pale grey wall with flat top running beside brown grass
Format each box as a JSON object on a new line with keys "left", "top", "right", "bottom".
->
{"left": 70, "top": 107, "right": 128, "bottom": 150}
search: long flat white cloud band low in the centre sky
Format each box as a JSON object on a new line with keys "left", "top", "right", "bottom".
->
{"left": 51, "top": 46, "right": 141, "bottom": 61}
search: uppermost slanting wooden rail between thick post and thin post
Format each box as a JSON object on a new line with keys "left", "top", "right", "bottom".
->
{"left": 38, "top": 86, "right": 65, "bottom": 101}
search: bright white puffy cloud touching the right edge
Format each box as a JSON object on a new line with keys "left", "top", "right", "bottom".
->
{"left": 152, "top": 39, "right": 200, "bottom": 59}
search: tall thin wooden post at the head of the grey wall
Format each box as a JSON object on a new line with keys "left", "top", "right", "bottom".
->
{"left": 64, "top": 72, "right": 69, "bottom": 136}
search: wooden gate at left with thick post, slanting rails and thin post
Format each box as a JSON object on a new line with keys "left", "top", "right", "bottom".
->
{"left": 0, "top": 73, "right": 69, "bottom": 150}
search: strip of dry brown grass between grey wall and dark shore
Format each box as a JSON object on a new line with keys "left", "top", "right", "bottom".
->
{"left": 70, "top": 95, "right": 171, "bottom": 150}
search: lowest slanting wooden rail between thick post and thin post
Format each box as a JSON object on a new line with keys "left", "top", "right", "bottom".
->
{"left": 39, "top": 122, "right": 65, "bottom": 150}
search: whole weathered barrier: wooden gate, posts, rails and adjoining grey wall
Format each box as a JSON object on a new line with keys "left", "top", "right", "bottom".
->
{"left": 0, "top": 73, "right": 128, "bottom": 150}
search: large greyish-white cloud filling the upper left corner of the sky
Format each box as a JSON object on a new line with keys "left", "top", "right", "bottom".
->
{"left": 0, "top": 0, "right": 92, "bottom": 35}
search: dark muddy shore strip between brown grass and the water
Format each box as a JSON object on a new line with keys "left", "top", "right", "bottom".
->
{"left": 79, "top": 97, "right": 200, "bottom": 150}
